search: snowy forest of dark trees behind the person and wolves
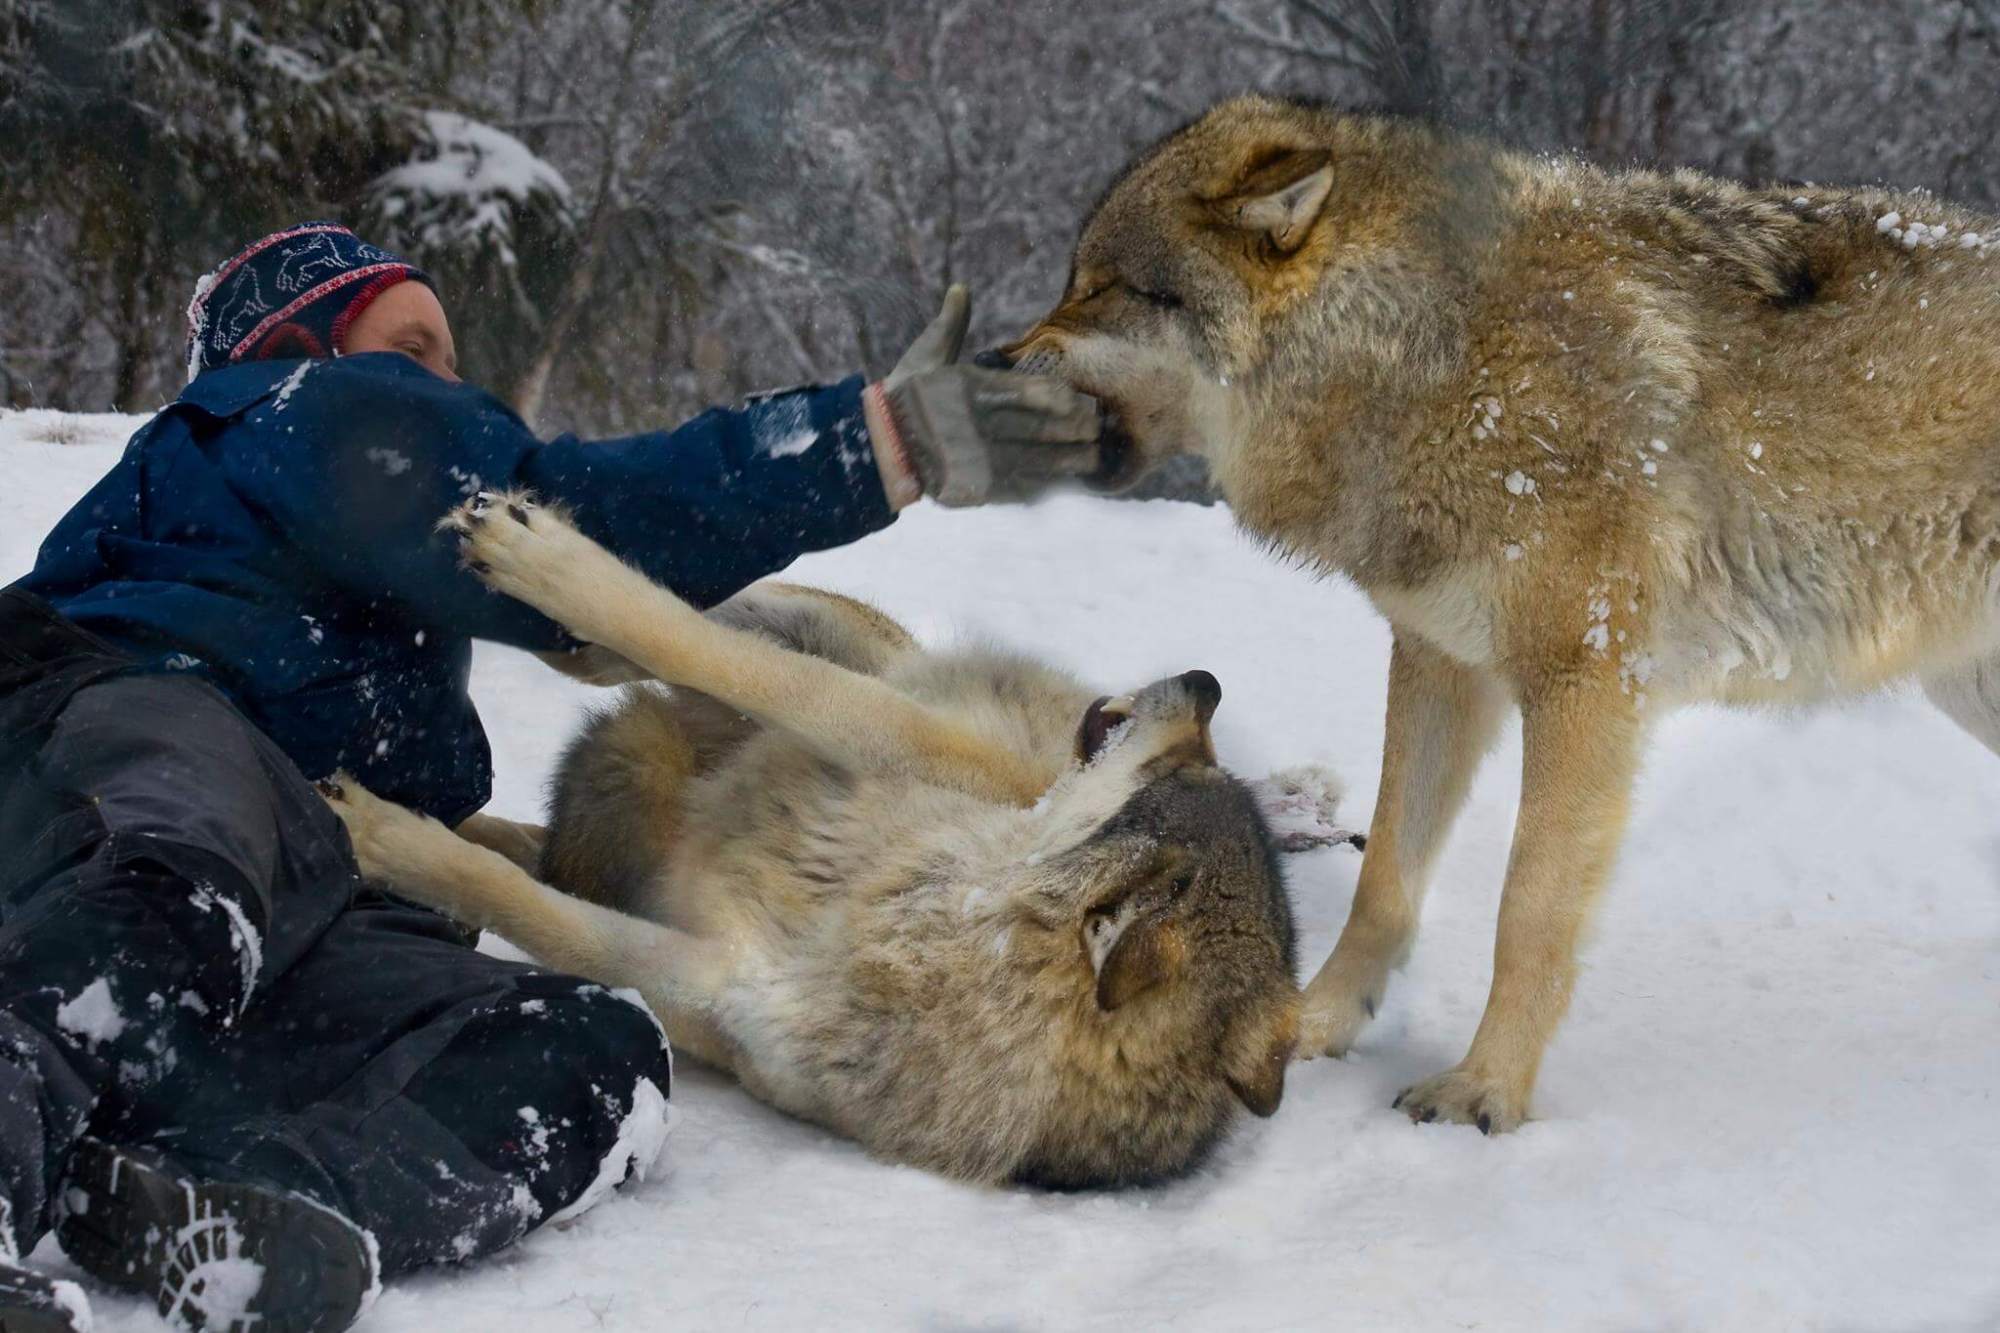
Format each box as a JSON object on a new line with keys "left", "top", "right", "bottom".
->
{"left": 0, "top": 0, "right": 2000, "bottom": 432}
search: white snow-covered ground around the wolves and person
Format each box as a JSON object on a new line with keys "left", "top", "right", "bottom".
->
{"left": 0, "top": 414, "right": 2000, "bottom": 1333}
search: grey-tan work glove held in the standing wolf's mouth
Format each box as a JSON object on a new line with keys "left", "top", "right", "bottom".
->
{"left": 862, "top": 282, "right": 1100, "bottom": 508}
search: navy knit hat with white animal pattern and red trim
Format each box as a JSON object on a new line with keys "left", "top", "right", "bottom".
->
{"left": 188, "top": 222, "right": 436, "bottom": 380}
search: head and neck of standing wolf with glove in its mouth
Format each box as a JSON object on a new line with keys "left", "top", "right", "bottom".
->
{"left": 1004, "top": 96, "right": 1496, "bottom": 488}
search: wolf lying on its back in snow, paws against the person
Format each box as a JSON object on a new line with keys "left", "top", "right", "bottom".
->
{"left": 330, "top": 490, "right": 1298, "bottom": 1187}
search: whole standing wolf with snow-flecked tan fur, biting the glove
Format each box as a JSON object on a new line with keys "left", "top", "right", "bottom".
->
{"left": 1012, "top": 98, "right": 2000, "bottom": 1129}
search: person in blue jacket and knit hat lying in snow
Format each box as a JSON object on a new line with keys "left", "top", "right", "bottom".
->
{"left": 0, "top": 222, "right": 1096, "bottom": 1333}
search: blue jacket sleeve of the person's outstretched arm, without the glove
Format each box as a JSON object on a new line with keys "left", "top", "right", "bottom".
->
{"left": 226, "top": 354, "right": 894, "bottom": 650}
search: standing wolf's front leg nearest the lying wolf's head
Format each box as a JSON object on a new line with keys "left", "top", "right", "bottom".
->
{"left": 1298, "top": 630, "right": 1506, "bottom": 1059}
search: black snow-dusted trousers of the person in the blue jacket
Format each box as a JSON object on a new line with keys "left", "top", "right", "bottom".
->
{"left": 0, "top": 590, "right": 668, "bottom": 1275}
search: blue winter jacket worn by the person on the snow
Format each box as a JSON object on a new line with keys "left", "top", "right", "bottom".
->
{"left": 20, "top": 352, "right": 892, "bottom": 823}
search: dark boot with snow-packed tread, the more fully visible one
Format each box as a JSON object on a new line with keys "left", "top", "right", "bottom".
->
{"left": 53, "top": 1139, "right": 380, "bottom": 1333}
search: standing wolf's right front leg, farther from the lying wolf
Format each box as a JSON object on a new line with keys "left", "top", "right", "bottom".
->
{"left": 1396, "top": 662, "right": 1640, "bottom": 1133}
